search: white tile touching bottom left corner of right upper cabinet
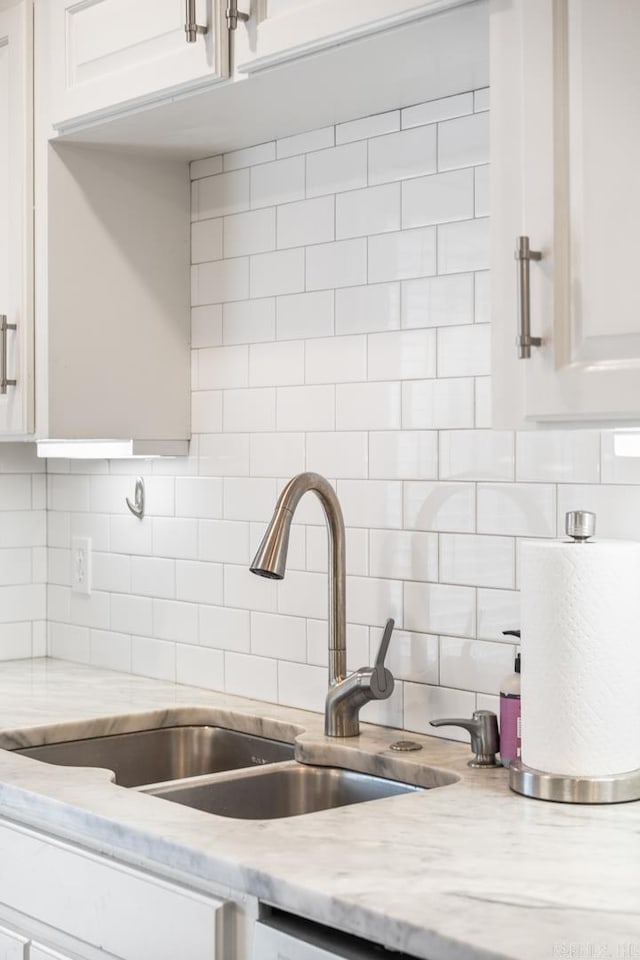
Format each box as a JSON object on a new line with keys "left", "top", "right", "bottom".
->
{"left": 440, "top": 430, "right": 514, "bottom": 480}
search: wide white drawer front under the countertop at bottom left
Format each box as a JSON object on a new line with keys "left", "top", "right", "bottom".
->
{"left": 0, "top": 826, "right": 230, "bottom": 960}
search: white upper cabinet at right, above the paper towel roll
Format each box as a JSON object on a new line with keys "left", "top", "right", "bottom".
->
{"left": 491, "top": 0, "right": 640, "bottom": 427}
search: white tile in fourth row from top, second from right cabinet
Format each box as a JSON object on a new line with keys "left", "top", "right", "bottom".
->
{"left": 368, "top": 227, "right": 436, "bottom": 283}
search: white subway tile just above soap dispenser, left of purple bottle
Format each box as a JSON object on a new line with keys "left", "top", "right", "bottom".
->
{"left": 440, "top": 637, "right": 514, "bottom": 694}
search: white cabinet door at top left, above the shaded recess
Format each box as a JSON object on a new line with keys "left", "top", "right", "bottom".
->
{"left": 50, "top": 0, "right": 229, "bottom": 129}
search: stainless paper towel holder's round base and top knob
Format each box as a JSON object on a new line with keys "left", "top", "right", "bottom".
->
{"left": 509, "top": 510, "right": 640, "bottom": 803}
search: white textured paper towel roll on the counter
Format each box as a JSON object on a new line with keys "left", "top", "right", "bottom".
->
{"left": 520, "top": 540, "right": 640, "bottom": 777}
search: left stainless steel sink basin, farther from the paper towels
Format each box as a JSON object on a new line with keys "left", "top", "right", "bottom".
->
{"left": 14, "top": 726, "right": 294, "bottom": 787}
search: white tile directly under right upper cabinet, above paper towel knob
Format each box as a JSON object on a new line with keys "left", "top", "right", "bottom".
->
{"left": 516, "top": 430, "right": 600, "bottom": 483}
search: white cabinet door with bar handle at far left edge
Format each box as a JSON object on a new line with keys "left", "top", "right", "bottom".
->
{"left": 0, "top": 4, "right": 33, "bottom": 435}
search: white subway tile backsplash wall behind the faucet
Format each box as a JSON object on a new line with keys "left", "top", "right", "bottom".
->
{"left": 41, "top": 90, "right": 640, "bottom": 739}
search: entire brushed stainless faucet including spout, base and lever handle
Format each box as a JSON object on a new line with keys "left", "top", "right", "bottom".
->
{"left": 250, "top": 473, "right": 394, "bottom": 737}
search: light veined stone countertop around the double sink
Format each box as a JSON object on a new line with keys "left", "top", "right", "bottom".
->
{"left": 0, "top": 660, "right": 640, "bottom": 960}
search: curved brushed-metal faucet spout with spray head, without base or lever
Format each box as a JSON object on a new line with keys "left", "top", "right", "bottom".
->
{"left": 250, "top": 473, "right": 347, "bottom": 686}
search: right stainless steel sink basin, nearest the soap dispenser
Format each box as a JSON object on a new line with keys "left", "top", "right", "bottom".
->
{"left": 144, "top": 762, "right": 424, "bottom": 820}
